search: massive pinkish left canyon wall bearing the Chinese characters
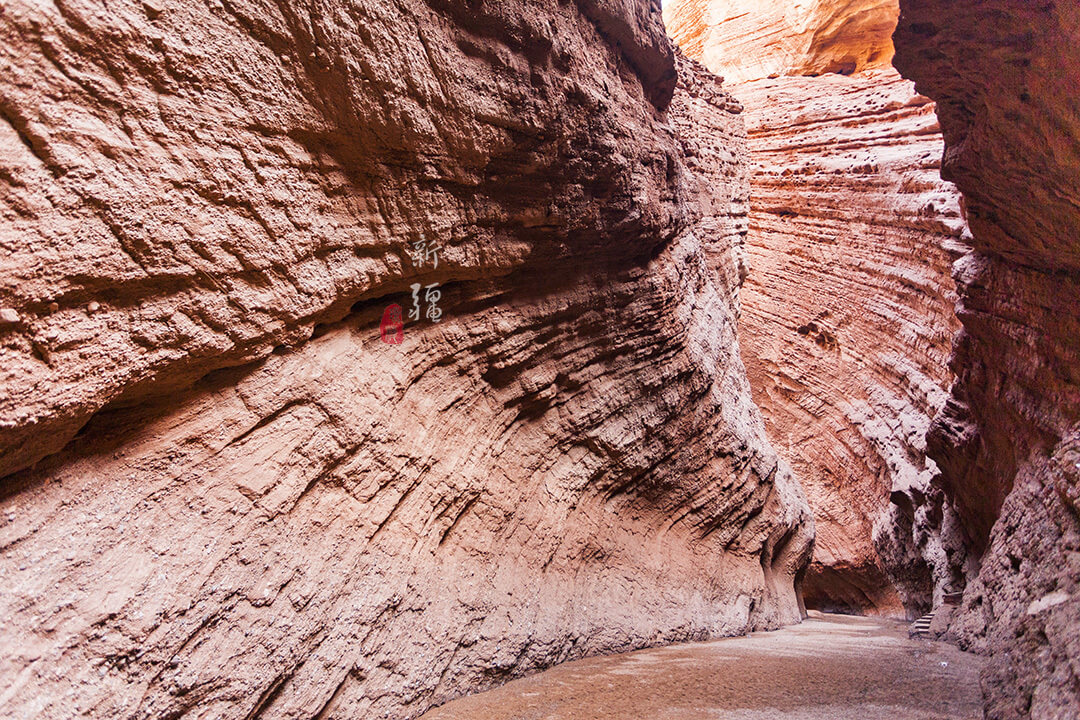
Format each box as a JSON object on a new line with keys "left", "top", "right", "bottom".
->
{"left": 0, "top": 0, "right": 812, "bottom": 719}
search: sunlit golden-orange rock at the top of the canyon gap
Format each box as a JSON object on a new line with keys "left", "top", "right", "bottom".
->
{"left": 664, "top": 0, "right": 899, "bottom": 82}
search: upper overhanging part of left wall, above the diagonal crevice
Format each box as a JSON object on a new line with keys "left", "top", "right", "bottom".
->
{"left": 0, "top": 0, "right": 681, "bottom": 483}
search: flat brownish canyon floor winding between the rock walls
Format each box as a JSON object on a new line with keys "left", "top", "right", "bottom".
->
{"left": 421, "top": 613, "right": 983, "bottom": 720}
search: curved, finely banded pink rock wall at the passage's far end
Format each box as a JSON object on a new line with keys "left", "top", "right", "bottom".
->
{"left": 732, "top": 70, "right": 964, "bottom": 615}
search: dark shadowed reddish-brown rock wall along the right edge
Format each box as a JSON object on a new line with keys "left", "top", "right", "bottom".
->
{"left": 896, "top": 0, "right": 1080, "bottom": 720}
